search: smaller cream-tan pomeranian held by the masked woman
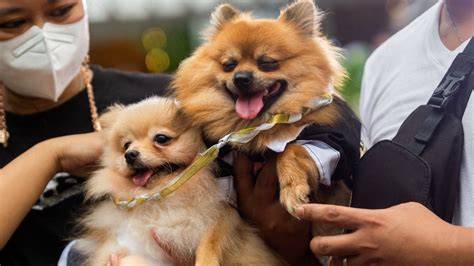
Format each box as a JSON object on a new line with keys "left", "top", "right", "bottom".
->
{"left": 80, "top": 97, "right": 282, "bottom": 266}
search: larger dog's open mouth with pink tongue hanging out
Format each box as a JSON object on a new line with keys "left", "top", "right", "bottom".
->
{"left": 234, "top": 80, "right": 286, "bottom": 120}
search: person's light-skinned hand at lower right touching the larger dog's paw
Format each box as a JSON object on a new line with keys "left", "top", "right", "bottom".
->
{"left": 296, "top": 202, "right": 474, "bottom": 266}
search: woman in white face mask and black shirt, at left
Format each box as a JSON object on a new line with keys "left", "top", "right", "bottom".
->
{"left": 0, "top": 0, "right": 169, "bottom": 265}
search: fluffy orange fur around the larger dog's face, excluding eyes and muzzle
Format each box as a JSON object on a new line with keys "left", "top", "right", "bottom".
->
{"left": 173, "top": 1, "right": 345, "bottom": 150}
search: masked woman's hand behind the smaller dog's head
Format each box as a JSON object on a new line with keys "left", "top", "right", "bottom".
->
{"left": 44, "top": 132, "right": 104, "bottom": 176}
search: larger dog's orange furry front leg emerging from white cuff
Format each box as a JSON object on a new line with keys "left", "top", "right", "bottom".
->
{"left": 277, "top": 144, "right": 319, "bottom": 217}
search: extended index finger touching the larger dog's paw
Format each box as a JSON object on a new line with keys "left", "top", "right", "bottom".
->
{"left": 296, "top": 203, "right": 371, "bottom": 229}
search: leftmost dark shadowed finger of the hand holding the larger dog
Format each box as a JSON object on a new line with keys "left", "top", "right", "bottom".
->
{"left": 233, "top": 154, "right": 254, "bottom": 198}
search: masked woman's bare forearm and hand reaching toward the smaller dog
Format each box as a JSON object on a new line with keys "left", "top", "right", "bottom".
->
{"left": 0, "top": 133, "right": 102, "bottom": 249}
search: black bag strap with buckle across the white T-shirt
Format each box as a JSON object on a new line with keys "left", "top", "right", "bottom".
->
{"left": 407, "top": 38, "right": 474, "bottom": 155}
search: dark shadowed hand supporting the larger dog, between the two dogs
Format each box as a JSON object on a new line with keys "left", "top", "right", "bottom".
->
{"left": 233, "top": 155, "right": 315, "bottom": 265}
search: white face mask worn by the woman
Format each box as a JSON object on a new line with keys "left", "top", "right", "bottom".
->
{"left": 0, "top": 14, "right": 89, "bottom": 101}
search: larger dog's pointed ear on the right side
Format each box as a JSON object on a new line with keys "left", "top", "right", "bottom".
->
{"left": 278, "top": 0, "right": 322, "bottom": 37}
